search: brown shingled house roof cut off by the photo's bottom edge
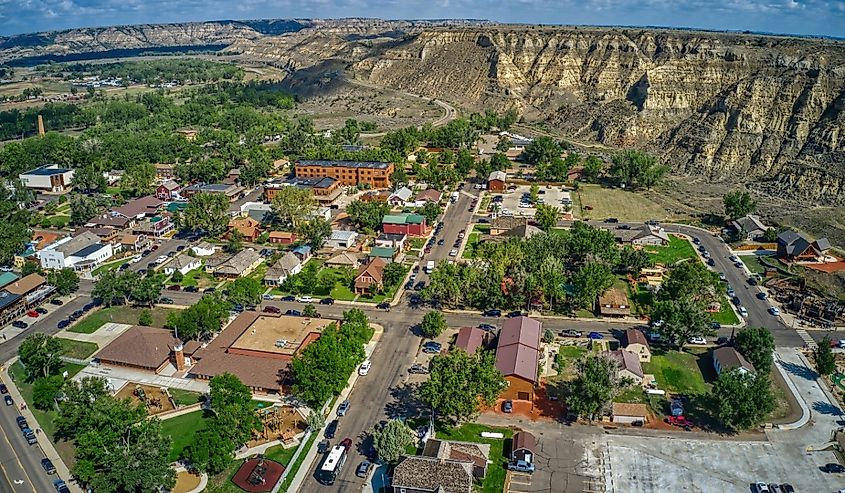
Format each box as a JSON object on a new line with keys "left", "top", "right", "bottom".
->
{"left": 390, "top": 456, "right": 473, "bottom": 493}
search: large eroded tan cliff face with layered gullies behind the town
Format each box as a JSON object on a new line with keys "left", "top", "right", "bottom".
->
{"left": 239, "top": 26, "right": 845, "bottom": 204}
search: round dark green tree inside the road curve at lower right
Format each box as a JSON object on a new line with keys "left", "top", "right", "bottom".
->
{"left": 710, "top": 368, "right": 775, "bottom": 430}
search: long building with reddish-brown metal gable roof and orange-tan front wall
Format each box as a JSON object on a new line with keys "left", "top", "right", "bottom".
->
{"left": 496, "top": 317, "right": 542, "bottom": 402}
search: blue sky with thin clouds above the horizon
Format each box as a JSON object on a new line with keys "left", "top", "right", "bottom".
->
{"left": 0, "top": 0, "right": 845, "bottom": 37}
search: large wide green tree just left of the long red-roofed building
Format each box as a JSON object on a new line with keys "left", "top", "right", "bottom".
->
{"left": 418, "top": 349, "right": 506, "bottom": 422}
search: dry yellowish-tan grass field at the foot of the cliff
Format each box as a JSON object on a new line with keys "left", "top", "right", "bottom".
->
{"left": 572, "top": 185, "right": 669, "bottom": 221}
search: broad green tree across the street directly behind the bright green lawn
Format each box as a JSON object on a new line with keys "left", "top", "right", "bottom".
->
{"left": 651, "top": 298, "right": 715, "bottom": 348}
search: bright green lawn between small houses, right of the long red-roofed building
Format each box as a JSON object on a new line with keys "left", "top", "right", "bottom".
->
{"left": 643, "top": 350, "right": 712, "bottom": 394}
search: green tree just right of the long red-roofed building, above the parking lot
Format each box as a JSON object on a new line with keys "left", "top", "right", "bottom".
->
{"left": 566, "top": 354, "right": 619, "bottom": 420}
